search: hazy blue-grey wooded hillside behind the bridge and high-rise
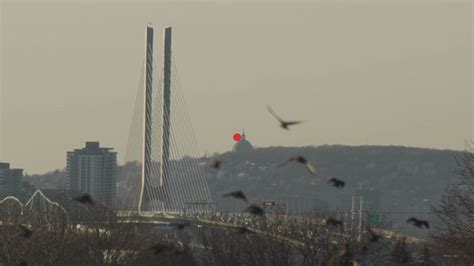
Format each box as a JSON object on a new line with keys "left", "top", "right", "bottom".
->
{"left": 25, "top": 145, "right": 461, "bottom": 235}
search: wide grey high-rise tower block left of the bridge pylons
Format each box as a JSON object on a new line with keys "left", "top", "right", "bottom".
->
{"left": 66, "top": 142, "right": 117, "bottom": 206}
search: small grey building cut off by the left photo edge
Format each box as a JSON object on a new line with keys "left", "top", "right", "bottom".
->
{"left": 0, "top": 163, "right": 23, "bottom": 198}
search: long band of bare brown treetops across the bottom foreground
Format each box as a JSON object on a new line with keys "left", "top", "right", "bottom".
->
{"left": 0, "top": 209, "right": 438, "bottom": 266}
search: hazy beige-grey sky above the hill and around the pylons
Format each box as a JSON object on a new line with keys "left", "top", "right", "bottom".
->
{"left": 0, "top": 0, "right": 473, "bottom": 173}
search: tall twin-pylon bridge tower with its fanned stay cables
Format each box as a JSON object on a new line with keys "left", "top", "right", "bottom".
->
{"left": 117, "top": 26, "right": 214, "bottom": 213}
